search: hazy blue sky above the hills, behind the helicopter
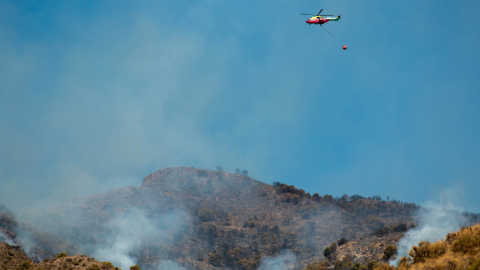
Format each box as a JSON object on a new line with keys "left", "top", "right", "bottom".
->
{"left": 0, "top": 0, "right": 480, "bottom": 212}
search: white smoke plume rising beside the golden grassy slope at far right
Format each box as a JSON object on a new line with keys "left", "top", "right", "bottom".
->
{"left": 390, "top": 203, "right": 464, "bottom": 266}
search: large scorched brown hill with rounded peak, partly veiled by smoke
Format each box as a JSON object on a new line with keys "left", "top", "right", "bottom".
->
{"left": 0, "top": 167, "right": 426, "bottom": 269}
